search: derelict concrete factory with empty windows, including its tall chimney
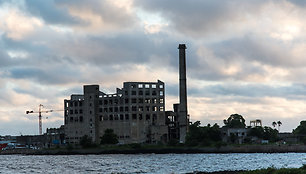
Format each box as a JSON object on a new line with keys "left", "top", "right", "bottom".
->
{"left": 64, "top": 44, "right": 189, "bottom": 144}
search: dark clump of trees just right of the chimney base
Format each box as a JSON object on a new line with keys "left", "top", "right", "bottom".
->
{"left": 186, "top": 114, "right": 278, "bottom": 146}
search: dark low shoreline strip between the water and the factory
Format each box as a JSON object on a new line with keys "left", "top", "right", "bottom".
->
{"left": 0, "top": 145, "right": 306, "bottom": 155}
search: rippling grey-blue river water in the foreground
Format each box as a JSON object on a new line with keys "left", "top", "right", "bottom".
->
{"left": 0, "top": 153, "right": 306, "bottom": 174}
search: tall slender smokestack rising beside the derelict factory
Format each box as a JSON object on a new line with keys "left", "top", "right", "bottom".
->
{"left": 178, "top": 44, "right": 189, "bottom": 143}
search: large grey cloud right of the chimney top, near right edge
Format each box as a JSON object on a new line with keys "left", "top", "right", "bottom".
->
{"left": 211, "top": 35, "right": 300, "bottom": 67}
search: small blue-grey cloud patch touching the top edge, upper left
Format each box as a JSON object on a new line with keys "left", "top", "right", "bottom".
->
{"left": 24, "top": 0, "right": 81, "bottom": 24}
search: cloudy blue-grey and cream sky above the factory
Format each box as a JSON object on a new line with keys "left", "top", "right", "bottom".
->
{"left": 0, "top": 0, "right": 306, "bottom": 135}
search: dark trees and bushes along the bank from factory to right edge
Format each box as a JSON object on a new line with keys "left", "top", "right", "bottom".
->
{"left": 75, "top": 114, "right": 306, "bottom": 149}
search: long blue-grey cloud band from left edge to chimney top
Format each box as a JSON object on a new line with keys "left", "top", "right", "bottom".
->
{"left": 1, "top": 31, "right": 178, "bottom": 66}
